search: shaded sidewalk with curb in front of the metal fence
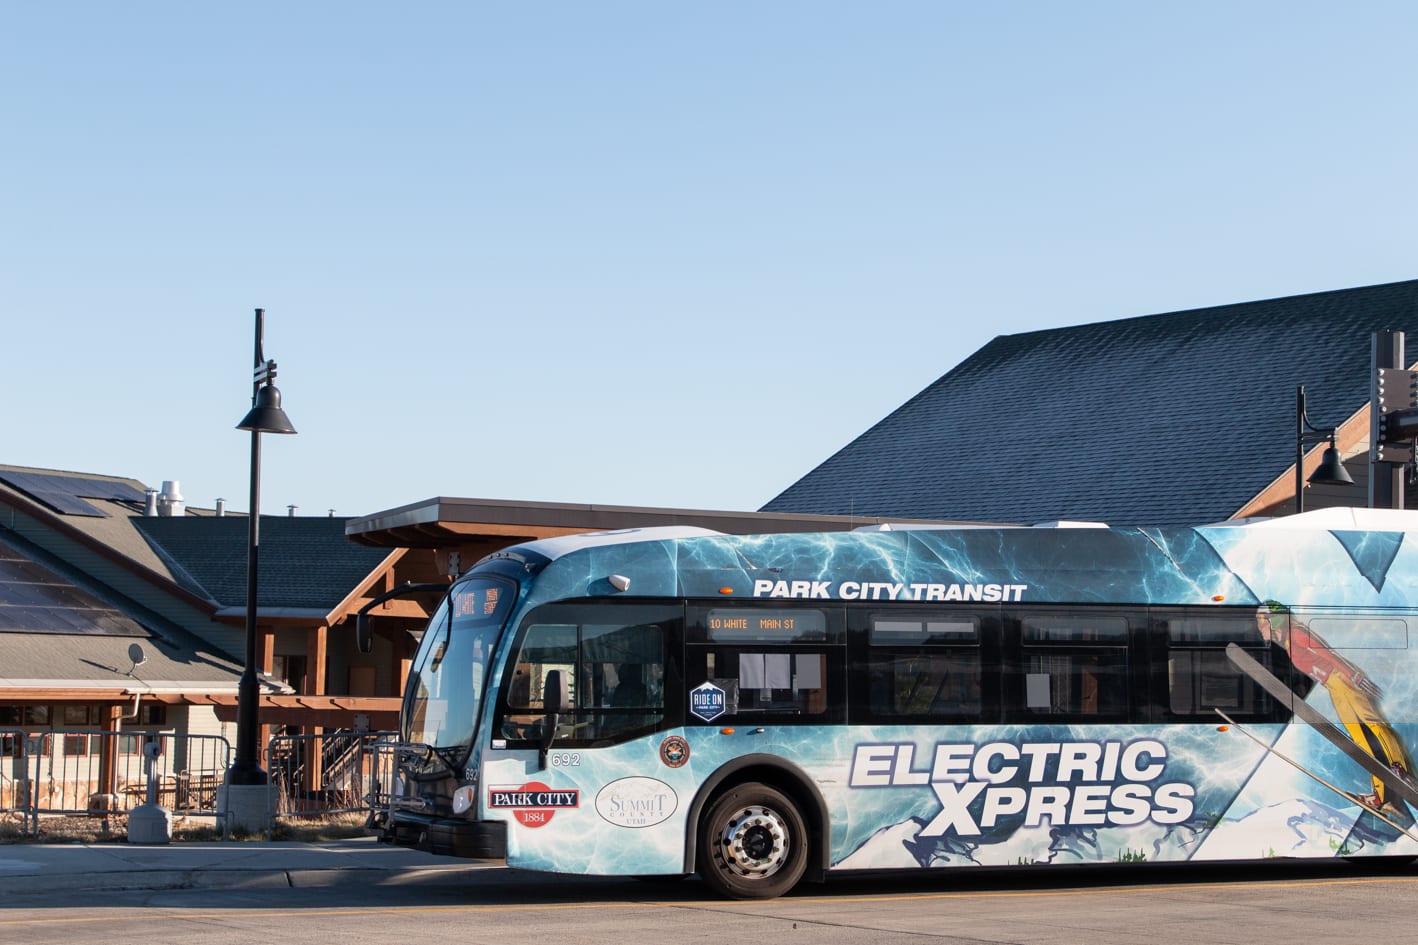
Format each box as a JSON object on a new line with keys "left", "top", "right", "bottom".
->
{"left": 0, "top": 837, "right": 489, "bottom": 904}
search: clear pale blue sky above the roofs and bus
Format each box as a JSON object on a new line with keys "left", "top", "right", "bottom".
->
{"left": 0, "top": 0, "right": 1418, "bottom": 515}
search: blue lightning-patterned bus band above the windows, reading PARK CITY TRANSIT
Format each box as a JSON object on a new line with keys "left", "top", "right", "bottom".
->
{"left": 484, "top": 508, "right": 1418, "bottom": 607}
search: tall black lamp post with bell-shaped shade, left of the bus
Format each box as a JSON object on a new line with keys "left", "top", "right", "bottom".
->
{"left": 227, "top": 308, "right": 295, "bottom": 785}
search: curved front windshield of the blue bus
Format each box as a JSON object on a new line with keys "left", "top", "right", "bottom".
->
{"left": 400, "top": 578, "right": 516, "bottom": 770}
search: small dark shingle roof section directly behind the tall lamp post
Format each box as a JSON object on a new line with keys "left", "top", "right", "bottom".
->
{"left": 133, "top": 515, "right": 390, "bottom": 610}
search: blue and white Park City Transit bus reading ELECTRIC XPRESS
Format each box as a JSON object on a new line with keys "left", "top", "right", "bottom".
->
{"left": 362, "top": 509, "right": 1418, "bottom": 898}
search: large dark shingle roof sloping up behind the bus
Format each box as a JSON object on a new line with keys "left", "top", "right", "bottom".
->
{"left": 763, "top": 281, "right": 1418, "bottom": 525}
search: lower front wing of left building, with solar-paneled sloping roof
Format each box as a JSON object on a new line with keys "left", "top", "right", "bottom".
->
{"left": 0, "top": 528, "right": 249, "bottom": 810}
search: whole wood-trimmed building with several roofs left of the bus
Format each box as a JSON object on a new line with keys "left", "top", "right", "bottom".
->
{"left": 0, "top": 465, "right": 432, "bottom": 783}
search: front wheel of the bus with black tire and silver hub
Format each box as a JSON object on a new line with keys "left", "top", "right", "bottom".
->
{"left": 699, "top": 783, "right": 807, "bottom": 900}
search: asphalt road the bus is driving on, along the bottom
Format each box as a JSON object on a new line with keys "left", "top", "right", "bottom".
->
{"left": 0, "top": 861, "right": 1418, "bottom": 945}
